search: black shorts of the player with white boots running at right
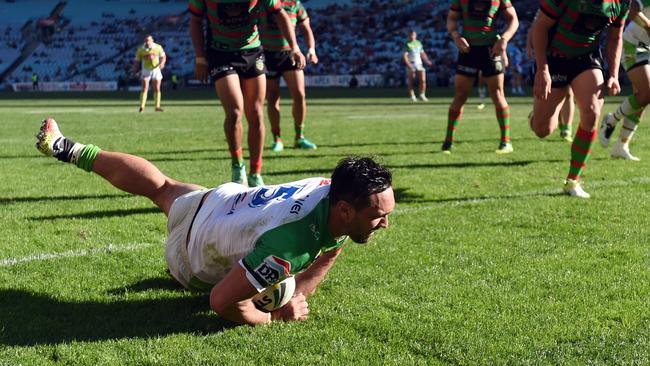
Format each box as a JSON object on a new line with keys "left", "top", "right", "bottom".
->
{"left": 546, "top": 51, "right": 603, "bottom": 88}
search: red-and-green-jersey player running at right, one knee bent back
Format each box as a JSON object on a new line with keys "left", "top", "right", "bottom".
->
{"left": 530, "top": 0, "right": 629, "bottom": 198}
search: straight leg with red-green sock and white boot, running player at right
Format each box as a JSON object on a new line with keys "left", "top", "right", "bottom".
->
{"left": 564, "top": 69, "right": 604, "bottom": 198}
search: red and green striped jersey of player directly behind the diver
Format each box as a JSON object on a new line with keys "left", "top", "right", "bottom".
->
{"left": 188, "top": 0, "right": 281, "bottom": 51}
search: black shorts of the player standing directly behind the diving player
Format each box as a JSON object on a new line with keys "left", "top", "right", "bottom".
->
{"left": 206, "top": 47, "right": 266, "bottom": 82}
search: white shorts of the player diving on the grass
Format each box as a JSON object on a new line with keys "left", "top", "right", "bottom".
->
{"left": 165, "top": 189, "right": 210, "bottom": 289}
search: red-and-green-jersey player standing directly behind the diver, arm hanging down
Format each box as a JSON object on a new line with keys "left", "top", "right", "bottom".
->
{"left": 189, "top": 0, "right": 305, "bottom": 187}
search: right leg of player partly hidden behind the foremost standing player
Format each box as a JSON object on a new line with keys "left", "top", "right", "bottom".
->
{"left": 283, "top": 70, "right": 316, "bottom": 149}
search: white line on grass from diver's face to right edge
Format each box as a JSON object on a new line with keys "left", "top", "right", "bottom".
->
{"left": 393, "top": 177, "right": 650, "bottom": 215}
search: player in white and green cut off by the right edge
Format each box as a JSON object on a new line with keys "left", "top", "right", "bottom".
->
{"left": 598, "top": 0, "right": 650, "bottom": 161}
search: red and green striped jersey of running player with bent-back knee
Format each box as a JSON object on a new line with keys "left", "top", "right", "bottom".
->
{"left": 540, "top": 0, "right": 630, "bottom": 58}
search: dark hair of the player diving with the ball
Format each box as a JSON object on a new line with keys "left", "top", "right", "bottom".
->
{"left": 330, "top": 156, "right": 392, "bottom": 209}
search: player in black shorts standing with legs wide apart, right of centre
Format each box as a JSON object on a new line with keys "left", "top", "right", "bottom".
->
{"left": 442, "top": 0, "right": 519, "bottom": 154}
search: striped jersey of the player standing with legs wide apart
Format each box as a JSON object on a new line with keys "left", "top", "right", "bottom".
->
{"left": 450, "top": 0, "right": 512, "bottom": 46}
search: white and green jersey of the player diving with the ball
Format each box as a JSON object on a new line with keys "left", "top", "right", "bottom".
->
{"left": 187, "top": 178, "right": 346, "bottom": 290}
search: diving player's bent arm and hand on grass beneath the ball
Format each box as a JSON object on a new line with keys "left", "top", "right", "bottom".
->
{"left": 210, "top": 265, "right": 309, "bottom": 325}
